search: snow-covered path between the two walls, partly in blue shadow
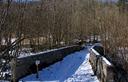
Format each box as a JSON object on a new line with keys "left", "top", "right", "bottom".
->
{"left": 19, "top": 49, "right": 99, "bottom": 82}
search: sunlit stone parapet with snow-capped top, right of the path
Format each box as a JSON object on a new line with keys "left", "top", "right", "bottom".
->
{"left": 89, "top": 46, "right": 114, "bottom": 82}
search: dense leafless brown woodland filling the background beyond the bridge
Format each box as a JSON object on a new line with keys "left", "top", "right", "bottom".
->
{"left": 0, "top": 0, "right": 128, "bottom": 75}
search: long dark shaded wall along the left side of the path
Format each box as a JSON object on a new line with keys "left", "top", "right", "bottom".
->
{"left": 12, "top": 45, "right": 82, "bottom": 81}
